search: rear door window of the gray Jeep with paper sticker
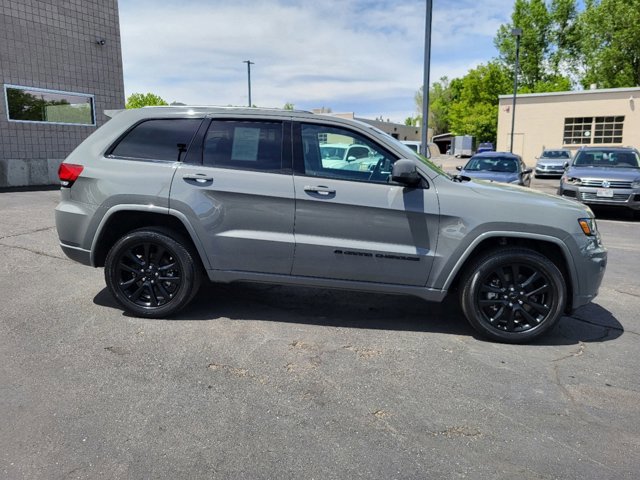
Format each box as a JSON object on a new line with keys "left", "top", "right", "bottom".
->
{"left": 204, "top": 120, "right": 282, "bottom": 172}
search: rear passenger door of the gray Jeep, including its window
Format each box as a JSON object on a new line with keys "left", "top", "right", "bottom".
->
{"left": 170, "top": 118, "right": 295, "bottom": 274}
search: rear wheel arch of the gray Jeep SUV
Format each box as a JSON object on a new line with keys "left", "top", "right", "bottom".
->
{"left": 91, "top": 205, "right": 208, "bottom": 268}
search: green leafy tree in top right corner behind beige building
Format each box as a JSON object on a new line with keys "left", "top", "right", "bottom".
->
{"left": 578, "top": 0, "right": 640, "bottom": 88}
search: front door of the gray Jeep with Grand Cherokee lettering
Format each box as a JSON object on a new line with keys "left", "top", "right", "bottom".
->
{"left": 292, "top": 123, "right": 439, "bottom": 286}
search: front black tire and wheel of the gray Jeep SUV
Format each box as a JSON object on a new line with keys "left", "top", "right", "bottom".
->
{"left": 460, "top": 248, "right": 567, "bottom": 343}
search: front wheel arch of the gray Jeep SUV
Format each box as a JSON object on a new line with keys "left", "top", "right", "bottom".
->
{"left": 444, "top": 232, "right": 577, "bottom": 312}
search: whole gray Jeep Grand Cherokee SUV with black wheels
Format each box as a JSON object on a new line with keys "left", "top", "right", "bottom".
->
{"left": 56, "top": 107, "right": 607, "bottom": 343}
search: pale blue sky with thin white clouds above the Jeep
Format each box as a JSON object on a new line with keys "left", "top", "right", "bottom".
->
{"left": 119, "top": 0, "right": 513, "bottom": 123}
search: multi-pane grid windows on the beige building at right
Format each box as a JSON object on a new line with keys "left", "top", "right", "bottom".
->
{"left": 563, "top": 116, "right": 624, "bottom": 145}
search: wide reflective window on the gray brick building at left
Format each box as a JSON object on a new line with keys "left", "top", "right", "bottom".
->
{"left": 4, "top": 85, "right": 96, "bottom": 125}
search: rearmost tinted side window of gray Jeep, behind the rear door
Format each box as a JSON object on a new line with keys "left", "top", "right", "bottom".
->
{"left": 110, "top": 118, "right": 202, "bottom": 162}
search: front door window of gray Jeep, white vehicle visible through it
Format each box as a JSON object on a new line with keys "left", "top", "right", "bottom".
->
{"left": 302, "top": 124, "right": 396, "bottom": 183}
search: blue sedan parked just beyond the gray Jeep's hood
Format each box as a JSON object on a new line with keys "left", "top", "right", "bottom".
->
{"left": 456, "top": 152, "right": 533, "bottom": 187}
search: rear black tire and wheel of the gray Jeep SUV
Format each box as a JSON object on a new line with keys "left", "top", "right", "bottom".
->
{"left": 104, "top": 228, "right": 202, "bottom": 318}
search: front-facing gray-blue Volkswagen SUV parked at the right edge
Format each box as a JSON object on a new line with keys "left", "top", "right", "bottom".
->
{"left": 558, "top": 147, "right": 640, "bottom": 212}
